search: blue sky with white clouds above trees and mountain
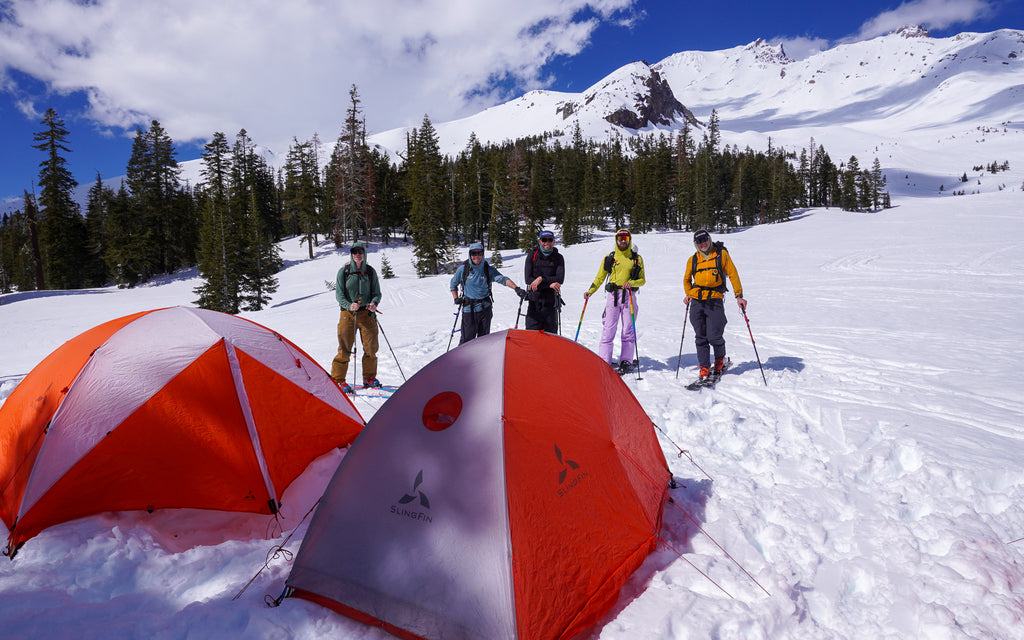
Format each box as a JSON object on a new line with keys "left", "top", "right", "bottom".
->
{"left": 0, "top": 0, "right": 1024, "bottom": 212}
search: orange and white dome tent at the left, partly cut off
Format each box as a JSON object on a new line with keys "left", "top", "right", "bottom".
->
{"left": 0, "top": 307, "right": 364, "bottom": 557}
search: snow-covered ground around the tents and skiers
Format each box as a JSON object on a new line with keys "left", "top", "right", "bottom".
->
{"left": 0, "top": 186, "right": 1024, "bottom": 640}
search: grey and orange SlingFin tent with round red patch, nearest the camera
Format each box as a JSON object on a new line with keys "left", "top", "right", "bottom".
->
{"left": 283, "top": 330, "right": 671, "bottom": 640}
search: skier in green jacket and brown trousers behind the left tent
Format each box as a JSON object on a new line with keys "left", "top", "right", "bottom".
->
{"left": 331, "top": 243, "right": 381, "bottom": 393}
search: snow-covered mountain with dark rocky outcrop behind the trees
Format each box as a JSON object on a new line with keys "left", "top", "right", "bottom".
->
{"left": 370, "top": 27, "right": 1024, "bottom": 184}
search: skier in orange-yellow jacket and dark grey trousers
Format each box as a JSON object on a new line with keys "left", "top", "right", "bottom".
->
{"left": 683, "top": 229, "right": 746, "bottom": 380}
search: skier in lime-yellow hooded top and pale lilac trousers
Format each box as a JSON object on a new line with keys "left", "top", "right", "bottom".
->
{"left": 583, "top": 229, "right": 646, "bottom": 374}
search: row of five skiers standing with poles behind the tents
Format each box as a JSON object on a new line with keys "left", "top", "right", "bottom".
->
{"left": 331, "top": 228, "right": 746, "bottom": 393}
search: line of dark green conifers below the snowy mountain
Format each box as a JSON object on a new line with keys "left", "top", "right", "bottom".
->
{"left": 0, "top": 90, "right": 889, "bottom": 294}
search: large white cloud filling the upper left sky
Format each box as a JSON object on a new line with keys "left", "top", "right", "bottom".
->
{"left": 0, "top": 0, "right": 636, "bottom": 152}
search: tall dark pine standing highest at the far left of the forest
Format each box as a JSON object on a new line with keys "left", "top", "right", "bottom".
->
{"left": 33, "top": 109, "right": 86, "bottom": 289}
